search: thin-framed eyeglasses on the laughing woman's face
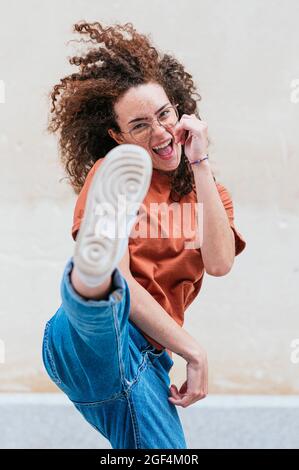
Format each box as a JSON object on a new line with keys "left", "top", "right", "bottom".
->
{"left": 120, "top": 104, "right": 179, "bottom": 144}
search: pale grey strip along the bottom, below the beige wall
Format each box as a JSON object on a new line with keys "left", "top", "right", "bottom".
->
{"left": 0, "top": 394, "right": 299, "bottom": 449}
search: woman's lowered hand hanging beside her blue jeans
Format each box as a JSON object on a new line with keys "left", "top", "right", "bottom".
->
{"left": 168, "top": 349, "right": 208, "bottom": 408}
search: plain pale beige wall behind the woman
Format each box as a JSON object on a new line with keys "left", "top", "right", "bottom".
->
{"left": 0, "top": 0, "right": 299, "bottom": 394}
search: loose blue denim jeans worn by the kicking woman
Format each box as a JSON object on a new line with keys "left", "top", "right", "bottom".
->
{"left": 42, "top": 258, "right": 187, "bottom": 449}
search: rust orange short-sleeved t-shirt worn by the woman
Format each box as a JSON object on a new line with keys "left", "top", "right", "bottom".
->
{"left": 72, "top": 158, "right": 246, "bottom": 349}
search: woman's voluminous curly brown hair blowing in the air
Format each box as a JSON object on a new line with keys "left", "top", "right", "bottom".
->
{"left": 47, "top": 21, "right": 215, "bottom": 200}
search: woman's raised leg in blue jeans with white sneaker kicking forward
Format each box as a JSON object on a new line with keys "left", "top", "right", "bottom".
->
{"left": 43, "top": 145, "right": 152, "bottom": 402}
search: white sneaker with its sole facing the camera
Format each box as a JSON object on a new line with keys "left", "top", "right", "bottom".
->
{"left": 74, "top": 144, "right": 152, "bottom": 287}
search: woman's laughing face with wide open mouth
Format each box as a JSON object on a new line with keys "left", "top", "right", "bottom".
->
{"left": 109, "top": 83, "right": 182, "bottom": 171}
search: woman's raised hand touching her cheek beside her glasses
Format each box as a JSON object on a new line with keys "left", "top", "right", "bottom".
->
{"left": 174, "top": 114, "right": 208, "bottom": 162}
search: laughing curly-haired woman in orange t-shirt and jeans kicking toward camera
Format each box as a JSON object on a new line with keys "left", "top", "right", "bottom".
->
{"left": 43, "top": 22, "right": 246, "bottom": 449}
